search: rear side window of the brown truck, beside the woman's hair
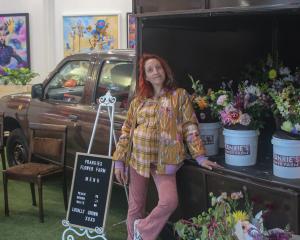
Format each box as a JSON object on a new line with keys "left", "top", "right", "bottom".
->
{"left": 96, "top": 60, "right": 133, "bottom": 108}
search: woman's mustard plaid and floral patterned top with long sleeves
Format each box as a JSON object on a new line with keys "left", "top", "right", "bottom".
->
{"left": 113, "top": 88, "right": 205, "bottom": 177}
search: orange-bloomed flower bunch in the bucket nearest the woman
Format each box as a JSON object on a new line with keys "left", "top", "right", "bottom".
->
{"left": 188, "top": 75, "right": 219, "bottom": 123}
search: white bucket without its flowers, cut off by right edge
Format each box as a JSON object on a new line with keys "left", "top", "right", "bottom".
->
{"left": 272, "top": 137, "right": 300, "bottom": 179}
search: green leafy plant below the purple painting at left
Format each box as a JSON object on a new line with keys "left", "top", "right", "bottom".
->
{"left": 0, "top": 67, "right": 39, "bottom": 85}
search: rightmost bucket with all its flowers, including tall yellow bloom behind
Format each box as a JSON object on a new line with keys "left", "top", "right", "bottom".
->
{"left": 247, "top": 55, "right": 300, "bottom": 178}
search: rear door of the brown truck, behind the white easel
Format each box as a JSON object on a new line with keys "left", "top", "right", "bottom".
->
{"left": 72, "top": 60, "right": 133, "bottom": 158}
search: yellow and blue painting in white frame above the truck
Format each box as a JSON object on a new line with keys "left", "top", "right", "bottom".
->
{"left": 63, "top": 14, "right": 120, "bottom": 56}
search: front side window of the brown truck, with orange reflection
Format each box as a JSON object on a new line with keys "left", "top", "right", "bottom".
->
{"left": 46, "top": 61, "right": 90, "bottom": 103}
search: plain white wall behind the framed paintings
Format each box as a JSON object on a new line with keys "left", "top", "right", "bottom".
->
{"left": 0, "top": 0, "right": 132, "bottom": 83}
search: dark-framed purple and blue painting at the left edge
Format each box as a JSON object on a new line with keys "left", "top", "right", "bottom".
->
{"left": 0, "top": 13, "right": 30, "bottom": 70}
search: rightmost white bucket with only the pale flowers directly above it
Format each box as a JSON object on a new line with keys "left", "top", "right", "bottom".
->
{"left": 270, "top": 84, "right": 300, "bottom": 178}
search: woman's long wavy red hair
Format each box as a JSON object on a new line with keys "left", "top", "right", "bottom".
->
{"left": 136, "top": 54, "right": 176, "bottom": 98}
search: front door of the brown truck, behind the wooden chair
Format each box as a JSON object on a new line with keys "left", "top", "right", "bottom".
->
{"left": 28, "top": 59, "right": 94, "bottom": 167}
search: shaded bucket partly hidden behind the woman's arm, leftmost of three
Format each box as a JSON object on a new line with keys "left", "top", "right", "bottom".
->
{"left": 199, "top": 122, "right": 221, "bottom": 156}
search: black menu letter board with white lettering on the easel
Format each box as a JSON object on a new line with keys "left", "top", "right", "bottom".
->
{"left": 67, "top": 153, "right": 113, "bottom": 230}
